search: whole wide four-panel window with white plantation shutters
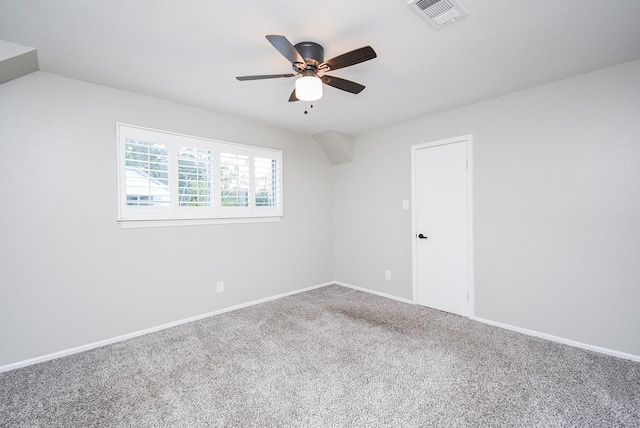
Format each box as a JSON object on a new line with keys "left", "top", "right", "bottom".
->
{"left": 117, "top": 124, "right": 282, "bottom": 226}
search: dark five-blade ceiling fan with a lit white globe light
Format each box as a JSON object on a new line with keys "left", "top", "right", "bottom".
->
{"left": 236, "top": 35, "right": 377, "bottom": 102}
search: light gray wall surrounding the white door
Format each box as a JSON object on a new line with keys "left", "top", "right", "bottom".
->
{"left": 334, "top": 61, "right": 640, "bottom": 355}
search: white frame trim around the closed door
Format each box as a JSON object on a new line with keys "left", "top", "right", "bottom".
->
{"left": 411, "top": 134, "right": 475, "bottom": 318}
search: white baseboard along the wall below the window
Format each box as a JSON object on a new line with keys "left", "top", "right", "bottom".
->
{"left": 0, "top": 281, "right": 335, "bottom": 373}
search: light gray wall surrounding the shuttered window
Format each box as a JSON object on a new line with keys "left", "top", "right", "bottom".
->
{"left": 0, "top": 72, "right": 333, "bottom": 366}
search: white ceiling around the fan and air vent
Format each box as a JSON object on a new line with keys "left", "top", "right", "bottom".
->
{"left": 0, "top": 0, "right": 640, "bottom": 135}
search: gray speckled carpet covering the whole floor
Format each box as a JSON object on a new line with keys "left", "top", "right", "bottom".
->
{"left": 0, "top": 286, "right": 640, "bottom": 428}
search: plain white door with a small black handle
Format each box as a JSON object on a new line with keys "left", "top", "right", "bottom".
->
{"left": 412, "top": 136, "right": 471, "bottom": 316}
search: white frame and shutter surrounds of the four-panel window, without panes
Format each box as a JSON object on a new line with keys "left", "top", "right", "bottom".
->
{"left": 116, "top": 123, "right": 284, "bottom": 228}
